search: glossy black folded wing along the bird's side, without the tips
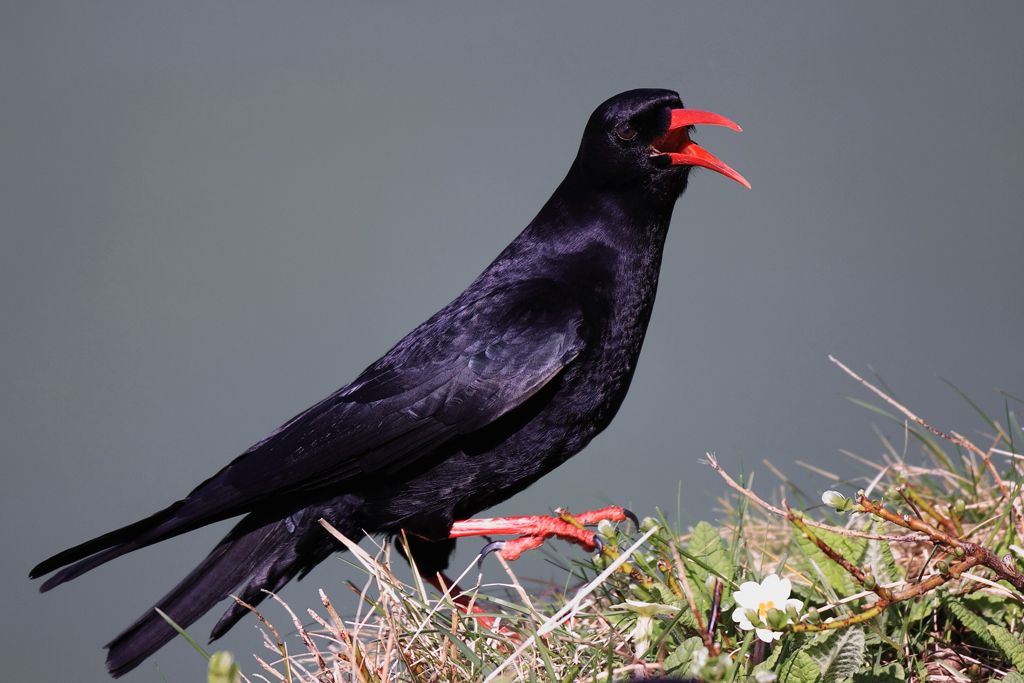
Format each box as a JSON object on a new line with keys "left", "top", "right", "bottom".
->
{"left": 164, "top": 280, "right": 585, "bottom": 522}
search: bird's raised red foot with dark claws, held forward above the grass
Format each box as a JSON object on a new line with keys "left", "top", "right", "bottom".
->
{"left": 450, "top": 506, "right": 639, "bottom": 561}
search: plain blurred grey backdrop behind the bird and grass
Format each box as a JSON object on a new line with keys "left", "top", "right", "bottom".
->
{"left": 0, "top": 0, "right": 1024, "bottom": 681}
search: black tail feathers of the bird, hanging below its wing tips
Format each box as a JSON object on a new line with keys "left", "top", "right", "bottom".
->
{"left": 100, "top": 514, "right": 333, "bottom": 677}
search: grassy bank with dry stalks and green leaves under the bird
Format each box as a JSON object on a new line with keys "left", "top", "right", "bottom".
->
{"left": 190, "top": 361, "right": 1024, "bottom": 683}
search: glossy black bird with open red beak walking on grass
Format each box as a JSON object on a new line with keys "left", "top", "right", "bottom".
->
{"left": 30, "top": 89, "right": 750, "bottom": 677}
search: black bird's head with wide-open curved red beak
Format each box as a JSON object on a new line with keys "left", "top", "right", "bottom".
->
{"left": 573, "top": 89, "right": 751, "bottom": 200}
